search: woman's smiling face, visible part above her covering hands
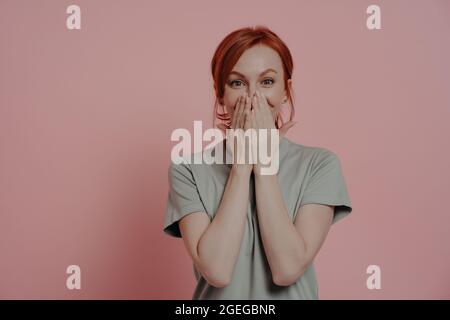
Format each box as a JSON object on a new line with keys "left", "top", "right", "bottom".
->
{"left": 223, "top": 45, "right": 291, "bottom": 121}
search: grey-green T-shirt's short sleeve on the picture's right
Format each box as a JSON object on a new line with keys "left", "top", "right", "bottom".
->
{"left": 300, "top": 149, "right": 352, "bottom": 224}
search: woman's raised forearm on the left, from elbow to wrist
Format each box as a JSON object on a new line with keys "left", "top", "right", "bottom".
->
{"left": 197, "top": 170, "right": 250, "bottom": 283}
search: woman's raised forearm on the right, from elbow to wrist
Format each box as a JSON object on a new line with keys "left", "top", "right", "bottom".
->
{"left": 255, "top": 175, "right": 306, "bottom": 285}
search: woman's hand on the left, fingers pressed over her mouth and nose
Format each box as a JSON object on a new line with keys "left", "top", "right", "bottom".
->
{"left": 226, "top": 94, "right": 253, "bottom": 176}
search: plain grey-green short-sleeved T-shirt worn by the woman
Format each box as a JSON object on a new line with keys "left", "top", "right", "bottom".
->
{"left": 163, "top": 137, "right": 352, "bottom": 300}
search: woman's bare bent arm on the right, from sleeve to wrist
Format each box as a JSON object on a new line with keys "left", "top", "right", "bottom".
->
{"left": 255, "top": 175, "right": 333, "bottom": 286}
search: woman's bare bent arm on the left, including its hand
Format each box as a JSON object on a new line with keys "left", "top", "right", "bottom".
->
{"left": 180, "top": 93, "right": 252, "bottom": 287}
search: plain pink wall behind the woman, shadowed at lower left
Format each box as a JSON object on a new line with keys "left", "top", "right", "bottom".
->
{"left": 0, "top": 0, "right": 450, "bottom": 299}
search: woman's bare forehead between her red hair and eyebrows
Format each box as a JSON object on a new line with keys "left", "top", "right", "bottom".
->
{"left": 232, "top": 45, "right": 283, "bottom": 75}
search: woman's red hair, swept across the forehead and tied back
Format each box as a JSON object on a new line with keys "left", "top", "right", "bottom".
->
{"left": 211, "top": 26, "right": 295, "bottom": 129}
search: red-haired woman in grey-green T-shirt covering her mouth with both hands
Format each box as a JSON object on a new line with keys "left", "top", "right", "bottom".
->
{"left": 164, "top": 27, "right": 352, "bottom": 299}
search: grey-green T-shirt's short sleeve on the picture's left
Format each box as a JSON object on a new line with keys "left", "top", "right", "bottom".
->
{"left": 163, "top": 162, "right": 206, "bottom": 238}
